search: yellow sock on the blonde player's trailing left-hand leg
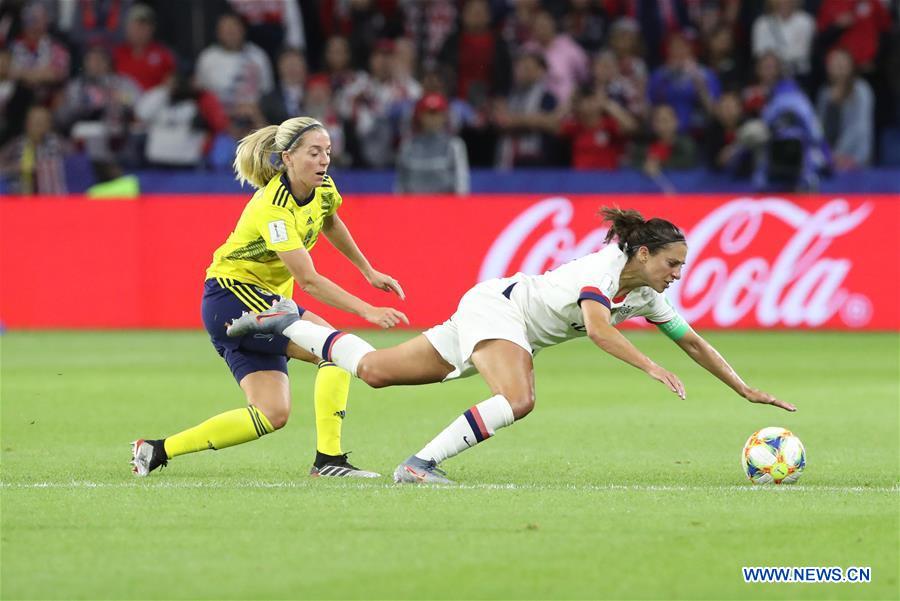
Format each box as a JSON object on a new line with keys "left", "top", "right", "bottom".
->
{"left": 165, "top": 405, "right": 275, "bottom": 459}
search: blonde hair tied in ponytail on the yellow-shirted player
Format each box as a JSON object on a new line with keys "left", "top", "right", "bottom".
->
{"left": 234, "top": 117, "right": 324, "bottom": 188}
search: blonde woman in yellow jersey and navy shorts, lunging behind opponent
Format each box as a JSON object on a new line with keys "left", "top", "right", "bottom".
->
{"left": 132, "top": 117, "right": 409, "bottom": 478}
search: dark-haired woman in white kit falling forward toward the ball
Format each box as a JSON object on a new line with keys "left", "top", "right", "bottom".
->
{"left": 228, "top": 208, "right": 795, "bottom": 484}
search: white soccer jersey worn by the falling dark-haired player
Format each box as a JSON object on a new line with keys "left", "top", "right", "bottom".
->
{"left": 506, "top": 244, "right": 677, "bottom": 351}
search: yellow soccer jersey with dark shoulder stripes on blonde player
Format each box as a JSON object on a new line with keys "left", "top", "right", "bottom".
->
{"left": 206, "top": 174, "right": 342, "bottom": 297}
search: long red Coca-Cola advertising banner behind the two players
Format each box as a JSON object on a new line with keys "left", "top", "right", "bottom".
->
{"left": 0, "top": 195, "right": 900, "bottom": 330}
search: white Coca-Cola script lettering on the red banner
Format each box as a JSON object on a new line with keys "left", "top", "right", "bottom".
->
{"left": 479, "top": 197, "right": 873, "bottom": 327}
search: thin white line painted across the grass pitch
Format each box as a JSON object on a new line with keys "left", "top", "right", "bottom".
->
{"left": 0, "top": 478, "right": 900, "bottom": 494}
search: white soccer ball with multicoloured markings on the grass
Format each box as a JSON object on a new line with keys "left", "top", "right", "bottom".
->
{"left": 741, "top": 427, "right": 806, "bottom": 484}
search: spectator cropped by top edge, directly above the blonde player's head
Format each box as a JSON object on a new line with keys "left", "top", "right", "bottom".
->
{"left": 228, "top": 0, "right": 306, "bottom": 63}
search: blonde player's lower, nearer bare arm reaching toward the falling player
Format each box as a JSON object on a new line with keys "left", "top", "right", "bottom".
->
{"left": 278, "top": 248, "right": 409, "bottom": 328}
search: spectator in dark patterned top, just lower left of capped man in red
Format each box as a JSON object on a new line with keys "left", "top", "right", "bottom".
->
{"left": 56, "top": 45, "right": 142, "bottom": 176}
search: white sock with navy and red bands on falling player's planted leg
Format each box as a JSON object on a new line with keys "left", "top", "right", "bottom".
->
{"left": 416, "top": 394, "right": 515, "bottom": 463}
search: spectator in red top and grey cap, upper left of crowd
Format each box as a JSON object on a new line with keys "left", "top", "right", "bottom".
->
{"left": 113, "top": 4, "right": 175, "bottom": 90}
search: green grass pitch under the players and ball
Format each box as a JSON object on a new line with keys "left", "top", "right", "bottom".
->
{"left": 0, "top": 332, "right": 900, "bottom": 599}
